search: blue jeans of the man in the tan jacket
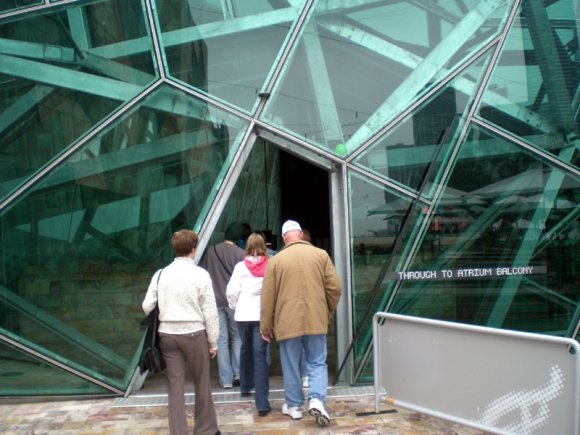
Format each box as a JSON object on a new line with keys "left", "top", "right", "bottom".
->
{"left": 280, "top": 335, "right": 328, "bottom": 406}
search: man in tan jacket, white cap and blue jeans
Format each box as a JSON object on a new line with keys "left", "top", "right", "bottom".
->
{"left": 260, "top": 220, "right": 341, "bottom": 426}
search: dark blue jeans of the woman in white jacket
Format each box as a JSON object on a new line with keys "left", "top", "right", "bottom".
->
{"left": 238, "top": 322, "right": 270, "bottom": 411}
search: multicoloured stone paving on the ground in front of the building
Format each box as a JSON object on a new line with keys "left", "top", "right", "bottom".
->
{"left": 0, "top": 395, "right": 490, "bottom": 435}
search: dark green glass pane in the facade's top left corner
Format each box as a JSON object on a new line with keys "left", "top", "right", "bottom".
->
{"left": 0, "top": 0, "right": 154, "bottom": 197}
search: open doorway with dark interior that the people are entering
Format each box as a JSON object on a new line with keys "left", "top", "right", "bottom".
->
{"left": 136, "top": 144, "right": 338, "bottom": 394}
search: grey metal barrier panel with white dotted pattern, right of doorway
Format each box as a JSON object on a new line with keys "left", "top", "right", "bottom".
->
{"left": 373, "top": 313, "right": 580, "bottom": 435}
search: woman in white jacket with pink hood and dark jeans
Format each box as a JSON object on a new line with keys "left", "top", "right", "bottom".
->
{"left": 226, "top": 233, "right": 271, "bottom": 417}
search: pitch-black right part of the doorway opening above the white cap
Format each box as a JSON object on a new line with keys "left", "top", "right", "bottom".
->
{"left": 280, "top": 151, "right": 330, "bottom": 253}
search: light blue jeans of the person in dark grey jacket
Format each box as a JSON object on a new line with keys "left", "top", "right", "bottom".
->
{"left": 217, "top": 308, "right": 242, "bottom": 385}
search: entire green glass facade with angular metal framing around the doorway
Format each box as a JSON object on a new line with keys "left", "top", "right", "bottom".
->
{"left": 0, "top": 0, "right": 580, "bottom": 396}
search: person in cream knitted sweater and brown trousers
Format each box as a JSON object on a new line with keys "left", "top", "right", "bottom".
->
{"left": 142, "top": 230, "right": 220, "bottom": 435}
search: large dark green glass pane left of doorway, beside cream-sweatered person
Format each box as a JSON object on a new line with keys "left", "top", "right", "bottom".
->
{"left": 0, "top": 88, "right": 243, "bottom": 394}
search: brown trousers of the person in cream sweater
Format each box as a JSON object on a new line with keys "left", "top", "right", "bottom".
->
{"left": 159, "top": 330, "right": 218, "bottom": 435}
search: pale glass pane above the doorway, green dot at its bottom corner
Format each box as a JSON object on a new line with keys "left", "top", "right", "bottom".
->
{"left": 266, "top": 0, "right": 510, "bottom": 157}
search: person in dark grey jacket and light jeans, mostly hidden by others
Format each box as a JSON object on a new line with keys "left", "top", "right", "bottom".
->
{"left": 200, "top": 222, "right": 246, "bottom": 389}
